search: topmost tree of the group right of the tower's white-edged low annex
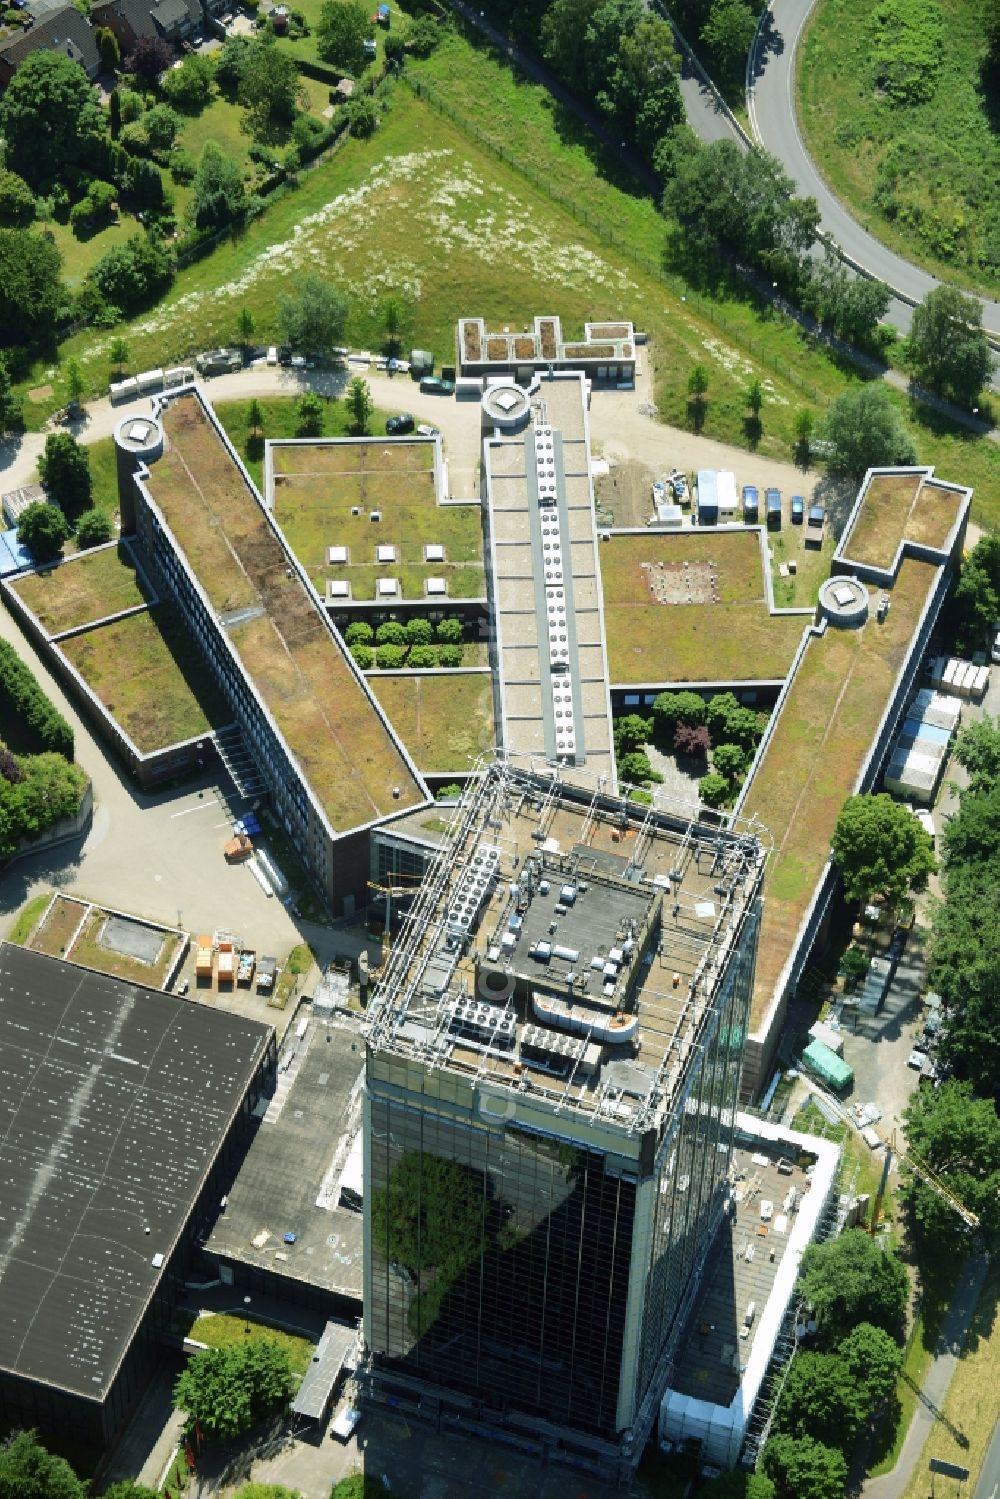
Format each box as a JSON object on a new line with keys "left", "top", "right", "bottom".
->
{"left": 801, "top": 1229, "right": 909, "bottom": 1348}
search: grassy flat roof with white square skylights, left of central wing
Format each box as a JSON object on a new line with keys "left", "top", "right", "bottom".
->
{"left": 273, "top": 439, "right": 486, "bottom": 600}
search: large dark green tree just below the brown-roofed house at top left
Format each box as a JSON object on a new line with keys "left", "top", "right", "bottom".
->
{"left": 0, "top": 48, "right": 103, "bottom": 183}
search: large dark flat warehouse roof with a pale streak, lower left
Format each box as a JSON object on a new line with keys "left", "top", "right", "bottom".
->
{"left": 0, "top": 943, "right": 271, "bottom": 1400}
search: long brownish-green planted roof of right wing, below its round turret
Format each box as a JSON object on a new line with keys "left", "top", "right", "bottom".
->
{"left": 741, "top": 558, "right": 936, "bottom": 1025}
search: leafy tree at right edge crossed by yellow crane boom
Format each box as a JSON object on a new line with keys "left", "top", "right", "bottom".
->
{"left": 903, "top": 1076, "right": 1000, "bottom": 1255}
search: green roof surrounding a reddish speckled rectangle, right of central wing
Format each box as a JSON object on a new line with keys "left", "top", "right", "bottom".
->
{"left": 600, "top": 531, "right": 808, "bottom": 687}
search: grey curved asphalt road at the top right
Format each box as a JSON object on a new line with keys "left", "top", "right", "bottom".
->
{"left": 747, "top": 0, "right": 1000, "bottom": 339}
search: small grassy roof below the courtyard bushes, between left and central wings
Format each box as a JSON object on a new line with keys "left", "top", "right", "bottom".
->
{"left": 369, "top": 672, "right": 496, "bottom": 773}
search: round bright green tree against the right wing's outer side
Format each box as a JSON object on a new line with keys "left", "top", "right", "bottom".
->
{"left": 832, "top": 791, "right": 937, "bottom": 904}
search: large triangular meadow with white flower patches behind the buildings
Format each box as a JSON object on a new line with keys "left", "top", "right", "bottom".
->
{"left": 27, "top": 76, "right": 844, "bottom": 457}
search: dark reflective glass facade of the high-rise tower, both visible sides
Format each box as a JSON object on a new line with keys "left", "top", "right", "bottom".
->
{"left": 364, "top": 908, "right": 759, "bottom": 1442}
